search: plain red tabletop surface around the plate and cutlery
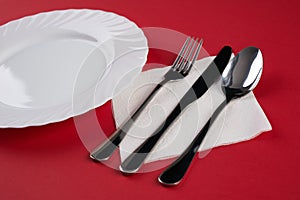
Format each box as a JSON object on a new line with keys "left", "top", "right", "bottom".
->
{"left": 0, "top": 0, "right": 300, "bottom": 200}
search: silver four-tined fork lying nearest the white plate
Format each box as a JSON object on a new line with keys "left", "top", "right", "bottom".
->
{"left": 90, "top": 37, "right": 203, "bottom": 161}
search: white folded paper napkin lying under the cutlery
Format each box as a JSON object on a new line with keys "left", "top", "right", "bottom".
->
{"left": 112, "top": 57, "right": 272, "bottom": 163}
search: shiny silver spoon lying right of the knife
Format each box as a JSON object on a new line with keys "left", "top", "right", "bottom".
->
{"left": 158, "top": 47, "right": 263, "bottom": 185}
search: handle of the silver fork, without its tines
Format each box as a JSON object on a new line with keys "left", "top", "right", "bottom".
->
{"left": 90, "top": 79, "right": 168, "bottom": 161}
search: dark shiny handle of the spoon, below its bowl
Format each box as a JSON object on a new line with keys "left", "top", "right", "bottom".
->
{"left": 158, "top": 100, "right": 228, "bottom": 185}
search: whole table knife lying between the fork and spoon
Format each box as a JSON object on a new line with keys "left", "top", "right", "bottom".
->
{"left": 120, "top": 46, "right": 232, "bottom": 173}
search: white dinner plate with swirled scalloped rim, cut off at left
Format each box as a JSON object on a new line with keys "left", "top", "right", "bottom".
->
{"left": 0, "top": 9, "right": 148, "bottom": 127}
